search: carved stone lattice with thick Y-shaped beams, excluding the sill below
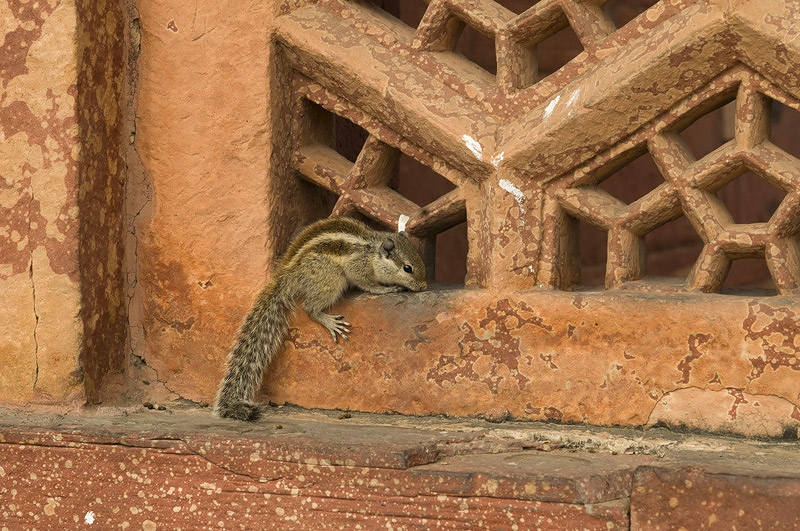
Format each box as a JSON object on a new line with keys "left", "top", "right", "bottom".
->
{"left": 278, "top": 0, "right": 800, "bottom": 294}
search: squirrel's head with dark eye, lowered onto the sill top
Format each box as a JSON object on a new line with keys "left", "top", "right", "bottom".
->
{"left": 375, "top": 232, "right": 428, "bottom": 291}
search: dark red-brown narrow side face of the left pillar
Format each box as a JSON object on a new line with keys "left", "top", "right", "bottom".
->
{"left": 77, "top": 0, "right": 129, "bottom": 401}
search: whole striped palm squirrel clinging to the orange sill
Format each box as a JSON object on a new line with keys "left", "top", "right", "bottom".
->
{"left": 214, "top": 218, "right": 427, "bottom": 422}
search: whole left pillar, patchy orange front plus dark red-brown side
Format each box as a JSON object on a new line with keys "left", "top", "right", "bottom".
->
{"left": 0, "top": 0, "right": 126, "bottom": 401}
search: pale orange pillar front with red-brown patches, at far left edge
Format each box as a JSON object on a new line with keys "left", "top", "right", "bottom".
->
{"left": 0, "top": 1, "right": 82, "bottom": 400}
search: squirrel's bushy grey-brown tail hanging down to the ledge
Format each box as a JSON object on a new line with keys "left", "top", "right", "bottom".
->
{"left": 214, "top": 277, "right": 293, "bottom": 422}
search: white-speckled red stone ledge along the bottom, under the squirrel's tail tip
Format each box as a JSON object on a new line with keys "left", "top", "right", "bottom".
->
{"left": 0, "top": 407, "right": 800, "bottom": 529}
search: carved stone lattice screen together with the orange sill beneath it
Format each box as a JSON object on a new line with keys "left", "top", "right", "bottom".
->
{"left": 267, "top": 0, "right": 800, "bottom": 433}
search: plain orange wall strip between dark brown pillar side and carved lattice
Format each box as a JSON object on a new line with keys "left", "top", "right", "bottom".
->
{"left": 127, "top": 1, "right": 278, "bottom": 398}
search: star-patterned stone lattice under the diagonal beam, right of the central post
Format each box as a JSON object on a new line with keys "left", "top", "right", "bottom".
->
{"left": 543, "top": 71, "right": 800, "bottom": 294}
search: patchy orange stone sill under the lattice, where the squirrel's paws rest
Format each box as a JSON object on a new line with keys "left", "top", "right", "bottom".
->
{"left": 255, "top": 290, "right": 800, "bottom": 437}
